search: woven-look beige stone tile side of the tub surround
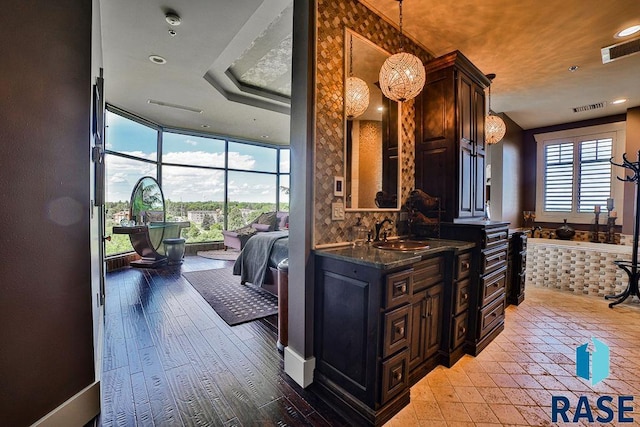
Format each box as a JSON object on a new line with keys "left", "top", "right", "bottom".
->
{"left": 525, "top": 238, "right": 637, "bottom": 302}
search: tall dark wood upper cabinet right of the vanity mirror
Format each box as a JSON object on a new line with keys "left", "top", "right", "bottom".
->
{"left": 415, "top": 51, "right": 490, "bottom": 221}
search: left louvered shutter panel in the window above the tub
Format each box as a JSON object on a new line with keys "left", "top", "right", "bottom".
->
{"left": 544, "top": 142, "right": 574, "bottom": 212}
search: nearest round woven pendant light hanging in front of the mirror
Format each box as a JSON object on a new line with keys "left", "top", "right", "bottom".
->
{"left": 379, "top": 0, "right": 425, "bottom": 102}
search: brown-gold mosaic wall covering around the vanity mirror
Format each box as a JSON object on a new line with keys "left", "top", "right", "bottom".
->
{"left": 314, "top": 0, "right": 432, "bottom": 245}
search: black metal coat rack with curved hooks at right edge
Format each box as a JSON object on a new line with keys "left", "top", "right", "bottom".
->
{"left": 605, "top": 150, "right": 640, "bottom": 308}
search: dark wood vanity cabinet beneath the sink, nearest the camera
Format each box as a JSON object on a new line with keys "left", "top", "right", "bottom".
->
{"left": 314, "top": 254, "right": 451, "bottom": 425}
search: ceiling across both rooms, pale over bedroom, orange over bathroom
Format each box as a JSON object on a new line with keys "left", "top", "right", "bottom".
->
{"left": 100, "top": 0, "right": 640, "bottom": 144}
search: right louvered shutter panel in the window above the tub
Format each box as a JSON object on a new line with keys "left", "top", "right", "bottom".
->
{"left": 578, "top": 138, "right": 613, "bottom": 212}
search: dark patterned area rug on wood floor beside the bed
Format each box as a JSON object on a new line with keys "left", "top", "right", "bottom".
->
{"left": 182, "top": 268, "right": 278, "bottom": 326}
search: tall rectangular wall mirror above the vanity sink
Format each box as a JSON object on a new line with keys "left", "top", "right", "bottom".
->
{"left": 343, "top": 29, "right": 402, "bottom": 211}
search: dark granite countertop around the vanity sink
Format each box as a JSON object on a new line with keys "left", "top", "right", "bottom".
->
{"left": 314, "top": 239, "right": 475, "bottom": 270}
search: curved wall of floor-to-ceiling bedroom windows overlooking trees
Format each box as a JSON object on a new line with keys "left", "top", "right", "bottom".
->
{"left": 105, "top": 107, "right": 290, "bottom": 255}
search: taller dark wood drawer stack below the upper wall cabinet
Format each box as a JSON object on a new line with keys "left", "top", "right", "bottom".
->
{"left": 441, "top": 221, "right": 509, "bottom": 356}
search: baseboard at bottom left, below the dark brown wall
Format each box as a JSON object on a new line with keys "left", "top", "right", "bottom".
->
{"left": 32, "top": 381, "right": 100, "bottom": 427}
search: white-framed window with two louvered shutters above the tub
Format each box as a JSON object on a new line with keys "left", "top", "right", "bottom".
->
{"left": 535, "top": 123, "right": 624, "bottom": 225}
